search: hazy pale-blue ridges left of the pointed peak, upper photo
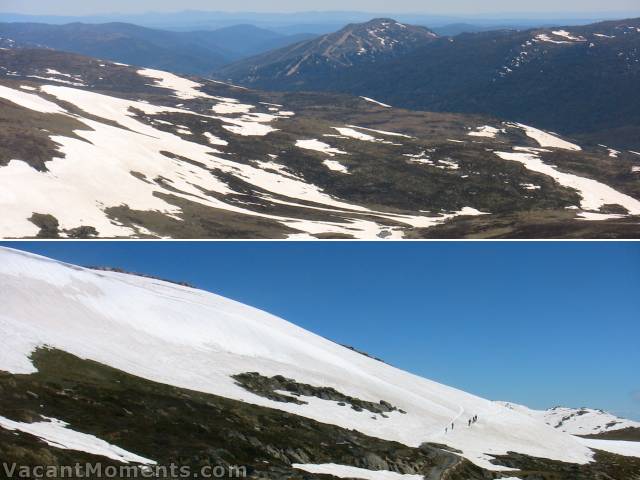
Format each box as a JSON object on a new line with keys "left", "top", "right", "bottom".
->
{"left": 0, "top": 23, "right": 314, "bottom": 75}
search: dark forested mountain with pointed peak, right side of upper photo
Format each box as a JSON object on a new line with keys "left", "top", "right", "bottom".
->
{"left": 219, "top": 19, "right": 640, "bottom": 149}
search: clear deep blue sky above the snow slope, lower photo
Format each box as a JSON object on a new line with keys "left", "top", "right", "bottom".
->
{"left": 0, "top": 242, "right": 640, "bottom": 420}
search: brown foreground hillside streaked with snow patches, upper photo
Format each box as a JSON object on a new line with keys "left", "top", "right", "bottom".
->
{"left": 0, "top": 46, "right": 640, "bottom": 239}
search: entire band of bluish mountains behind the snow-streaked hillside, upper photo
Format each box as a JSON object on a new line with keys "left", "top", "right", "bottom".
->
{"left": 6, "top": 14, "right": 640, "bottom": 151}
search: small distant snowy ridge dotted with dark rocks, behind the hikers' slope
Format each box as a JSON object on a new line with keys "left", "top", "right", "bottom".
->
{"left": 500, "top": 402, "right": 640, "bottom": 435}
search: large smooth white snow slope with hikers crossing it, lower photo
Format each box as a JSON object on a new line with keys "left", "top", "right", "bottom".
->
{"left": 0, "top": 249, "right": 592, "bottom": 469}
